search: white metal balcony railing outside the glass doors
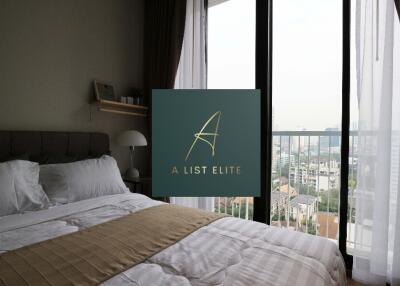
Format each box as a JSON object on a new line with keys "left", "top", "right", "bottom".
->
{"left": 215, "top": 131, "right": 358, "bottom": 244}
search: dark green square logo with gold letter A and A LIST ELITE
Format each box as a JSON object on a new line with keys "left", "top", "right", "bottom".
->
{"left": 152, "top": 89, "right": 260, "bottom": 197}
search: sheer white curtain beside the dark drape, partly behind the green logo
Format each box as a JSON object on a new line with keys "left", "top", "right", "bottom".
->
{"left": 170, "top": 0, "right": 214, "bottom": 211}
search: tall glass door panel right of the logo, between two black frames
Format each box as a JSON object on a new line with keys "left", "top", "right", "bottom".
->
{"left": 270, "top": 0, "right": 342, "bottom": 241}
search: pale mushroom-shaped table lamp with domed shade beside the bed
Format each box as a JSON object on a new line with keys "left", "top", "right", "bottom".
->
{"left": 117, "top": 130, "right": 147, "bottom": 179}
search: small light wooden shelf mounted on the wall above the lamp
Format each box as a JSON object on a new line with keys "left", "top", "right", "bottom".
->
{"left": 93, "top": 99, "right": 149, "bottom": 117}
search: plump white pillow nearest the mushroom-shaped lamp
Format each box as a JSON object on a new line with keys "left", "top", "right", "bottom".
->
{"left": 40, "top": 156, "right": 129, "bottom": 204}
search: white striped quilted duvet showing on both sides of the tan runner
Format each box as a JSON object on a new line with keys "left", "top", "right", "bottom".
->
{"left": 0, "top": 193, "right": 346, "bottom": 286}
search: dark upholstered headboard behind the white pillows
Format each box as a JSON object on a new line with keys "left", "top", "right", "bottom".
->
{"left": 0, "top": 131, "right": 110, "bottom": 164}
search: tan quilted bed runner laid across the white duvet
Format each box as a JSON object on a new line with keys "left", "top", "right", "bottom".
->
{"left": 0, "top": 205, "right": 223, "bottom": 286}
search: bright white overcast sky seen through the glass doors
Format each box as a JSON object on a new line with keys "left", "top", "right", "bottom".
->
{"left": 208, "top": 0, "right": 358, "bottom": 131}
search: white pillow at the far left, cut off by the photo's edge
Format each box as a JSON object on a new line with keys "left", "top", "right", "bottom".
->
{"left": 0, "top": 160, "right": 49, "bottom": 214}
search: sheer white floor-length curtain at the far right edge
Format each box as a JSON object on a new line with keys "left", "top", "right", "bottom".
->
{"left": 353, "top": 0, "right": 400, "bottom": 285}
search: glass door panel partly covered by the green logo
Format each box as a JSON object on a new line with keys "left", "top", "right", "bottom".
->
{"left": 207, "top": 0, "right": 256, "bottom": 219}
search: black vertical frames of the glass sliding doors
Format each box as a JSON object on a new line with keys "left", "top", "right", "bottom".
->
{"left": 253, "top": 0, "right": 353, "bottom": 273}
